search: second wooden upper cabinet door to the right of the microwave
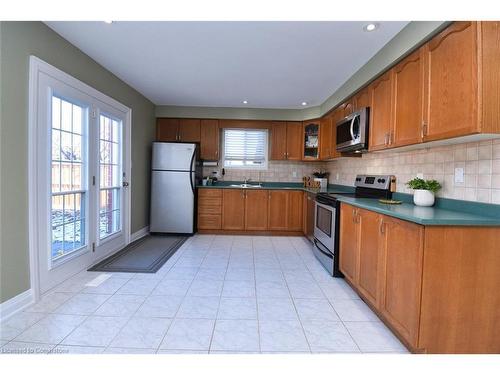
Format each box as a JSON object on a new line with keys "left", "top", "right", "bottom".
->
{"left": 392, "top": 49, "right": 424, "bottom": 146}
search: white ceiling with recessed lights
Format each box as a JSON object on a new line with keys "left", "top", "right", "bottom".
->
{"left": 47, "top": 21, "right": 408, "bottom": 108}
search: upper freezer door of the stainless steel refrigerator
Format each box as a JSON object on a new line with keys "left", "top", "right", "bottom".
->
{"left": 151, "top": 142, "right": 196, "bottom": 171}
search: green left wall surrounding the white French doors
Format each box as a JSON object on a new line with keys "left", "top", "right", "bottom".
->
{"left": 0, "top": 22, "right": 155, "bottom": 302}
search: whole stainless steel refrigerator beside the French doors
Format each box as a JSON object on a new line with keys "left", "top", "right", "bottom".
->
{"left": 149, "top": 142, "right": 201, "bottom": 234}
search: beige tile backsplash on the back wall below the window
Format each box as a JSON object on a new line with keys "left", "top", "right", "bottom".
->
{"left": 203, "top": 161, "right": 326, "bottom": 182}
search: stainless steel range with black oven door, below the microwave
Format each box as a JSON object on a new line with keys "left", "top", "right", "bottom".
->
{"left": 313, "top": 175, "right": 394, "bottom": 277}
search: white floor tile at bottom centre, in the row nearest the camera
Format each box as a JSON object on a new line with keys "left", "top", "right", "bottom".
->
{"left": 210, "top": 320, "right": 259, "bottom": 351}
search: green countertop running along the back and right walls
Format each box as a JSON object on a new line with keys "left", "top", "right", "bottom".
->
{"left": 198, "top": 181, "right": 500, "bottom": 226}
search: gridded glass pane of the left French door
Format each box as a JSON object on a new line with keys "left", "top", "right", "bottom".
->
{"left": 51, "top": 95, "right": 87, "bottom": 262}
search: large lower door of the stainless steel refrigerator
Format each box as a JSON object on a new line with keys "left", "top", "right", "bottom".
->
{"left": 149, "top": 170, "right": 194, "bottom": 234}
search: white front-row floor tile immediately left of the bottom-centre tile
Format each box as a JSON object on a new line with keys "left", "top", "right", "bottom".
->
{"left": 160, "top": 319, "right": 215, "bottom": 350}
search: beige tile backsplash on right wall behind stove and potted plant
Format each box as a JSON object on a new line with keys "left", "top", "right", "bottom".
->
{"left": 326, "top": 139, "right": 500, "bottom": 204}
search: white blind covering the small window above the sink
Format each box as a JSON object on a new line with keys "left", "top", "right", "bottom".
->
{"left": 223, "top": 129, "right": 267, "bottom": 169}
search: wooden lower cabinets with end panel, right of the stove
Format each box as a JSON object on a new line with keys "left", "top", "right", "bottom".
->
{"left": 339, "top": 203, "right": 500, "bottom": 354}
